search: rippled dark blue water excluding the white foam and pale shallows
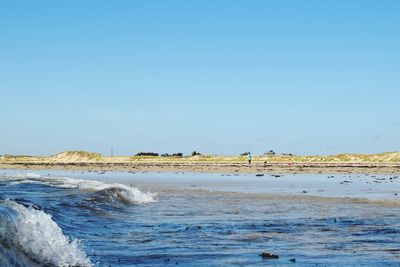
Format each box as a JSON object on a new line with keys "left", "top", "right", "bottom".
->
{"left": 0, "top": 173, "right": 400, "bottom": 266}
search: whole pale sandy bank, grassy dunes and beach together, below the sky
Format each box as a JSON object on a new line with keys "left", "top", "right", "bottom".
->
{"left": 0, "top": 151, "right": 400, "bottom": 174}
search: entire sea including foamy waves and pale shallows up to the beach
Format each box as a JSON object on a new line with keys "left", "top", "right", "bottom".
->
{"left": 0, "top": 170, "right": 400, "bottom": 266}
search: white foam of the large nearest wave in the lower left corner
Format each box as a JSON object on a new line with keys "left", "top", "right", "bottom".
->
{"left": 0, "top": 200, "right": 92, "bottom": 266}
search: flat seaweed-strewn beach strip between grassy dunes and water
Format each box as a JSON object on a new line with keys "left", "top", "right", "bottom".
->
{"left": 0, "top": 161, "right": 400, "bottom": 174}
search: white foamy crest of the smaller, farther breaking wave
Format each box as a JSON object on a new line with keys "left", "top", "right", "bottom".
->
{"left": 0, "top": 173, "right": 155, "bottom": 204}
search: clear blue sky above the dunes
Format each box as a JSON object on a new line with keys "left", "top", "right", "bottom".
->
{"left": 0, "top": 0, "right": 400, "bottom": 155}
